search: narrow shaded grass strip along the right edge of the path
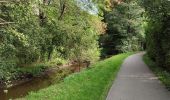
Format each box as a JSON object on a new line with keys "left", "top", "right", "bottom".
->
{"left": 143, "top": 54, "right": 170, "bottom": 90}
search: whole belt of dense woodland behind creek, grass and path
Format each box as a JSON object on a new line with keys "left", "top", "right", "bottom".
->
{"left": 0, "top": 0, "right": 170, "bottom": 86}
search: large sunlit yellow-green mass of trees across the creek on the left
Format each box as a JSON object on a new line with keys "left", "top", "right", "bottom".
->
{"left": 0, "top": 0, "right": 101, "bottom": 83}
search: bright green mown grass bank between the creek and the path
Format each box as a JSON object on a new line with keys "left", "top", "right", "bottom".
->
{"left": 25, "top": 53, "right": 132, "bottom": 100}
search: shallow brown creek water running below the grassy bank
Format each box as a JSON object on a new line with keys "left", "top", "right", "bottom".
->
{"left": 0, "top": 64, "right": 86, "bottom": 100}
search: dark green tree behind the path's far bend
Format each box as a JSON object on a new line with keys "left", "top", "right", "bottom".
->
{"left": 101, "top": 0, "right": 145, "bottom": 55}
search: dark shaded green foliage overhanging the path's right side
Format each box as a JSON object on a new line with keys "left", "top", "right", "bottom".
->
{"left": 142, "top": 0, "right": 170, "bottom": 69}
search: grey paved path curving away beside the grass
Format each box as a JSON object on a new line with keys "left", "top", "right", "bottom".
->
{"left": 106, "top": 53, "right": 170, "bottom": 100}
